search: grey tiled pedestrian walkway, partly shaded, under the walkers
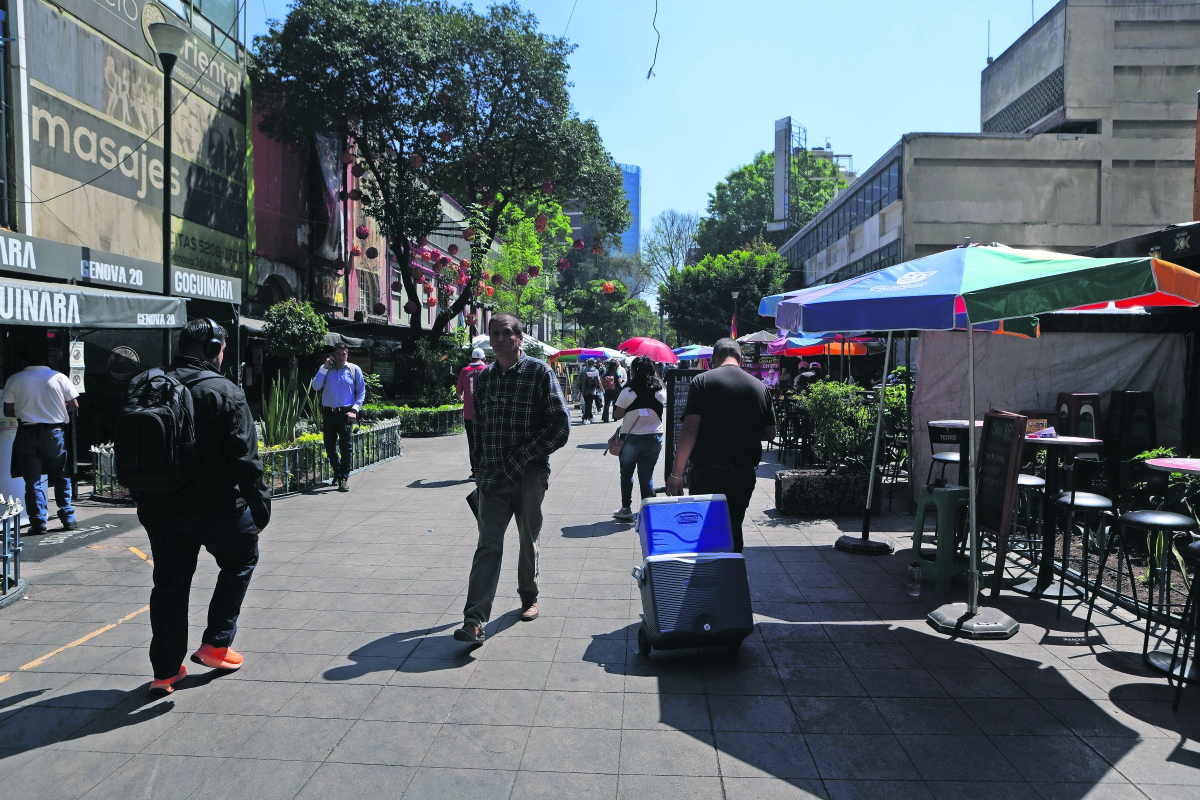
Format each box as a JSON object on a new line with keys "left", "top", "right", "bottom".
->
{"left": 0, "top": 425, "right": 1200, "bottom": 800}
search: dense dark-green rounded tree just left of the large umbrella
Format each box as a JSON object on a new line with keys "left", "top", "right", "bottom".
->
{"left": 659, "top": 244, "right": 786, "bottom": 343}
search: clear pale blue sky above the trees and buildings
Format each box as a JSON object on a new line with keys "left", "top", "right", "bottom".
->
{"left": 246, "top": 0, "right": 1054, "bottom": 241}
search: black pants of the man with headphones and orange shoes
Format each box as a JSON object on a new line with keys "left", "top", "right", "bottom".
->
{"left": 138, "top": 510, "right": 258, "bottom": 680}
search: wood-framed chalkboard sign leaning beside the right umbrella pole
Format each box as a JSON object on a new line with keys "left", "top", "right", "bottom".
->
{"left": 976, "top": 410, "right": 1026, "bottom": 597}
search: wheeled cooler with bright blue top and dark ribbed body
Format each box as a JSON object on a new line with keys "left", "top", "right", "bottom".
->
{"left": 634, "top": 494, "right": 754, "bottom": 656}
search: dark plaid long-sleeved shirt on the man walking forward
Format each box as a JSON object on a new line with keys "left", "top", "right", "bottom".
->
{"left": 473, "top": 353, "right": 571, "bottom": 489}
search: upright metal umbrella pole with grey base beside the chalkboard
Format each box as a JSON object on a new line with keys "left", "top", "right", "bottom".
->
{"left": 925, "top": 321, "right": 1021, "bottom": 639}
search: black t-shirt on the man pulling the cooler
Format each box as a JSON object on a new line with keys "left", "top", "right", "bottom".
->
{"left": 683, "top": 365, "right": 775, "bottom": 467}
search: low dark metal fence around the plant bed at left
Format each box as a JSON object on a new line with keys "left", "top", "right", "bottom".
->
{"left": 91, "top": 420, "right": 404, "bottom": 500}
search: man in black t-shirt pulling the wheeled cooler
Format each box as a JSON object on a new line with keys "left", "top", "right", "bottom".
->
{"left": 667, "top": 338, "right": 775, "bottom": 553}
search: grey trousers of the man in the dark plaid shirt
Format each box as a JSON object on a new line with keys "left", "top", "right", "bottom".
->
{"left": 462, "top": 473, "right": 550, "bottom": 625}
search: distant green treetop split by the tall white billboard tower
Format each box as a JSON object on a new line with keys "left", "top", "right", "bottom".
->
{"left": 696, "top": 150, "right": 846, "bottom": 255}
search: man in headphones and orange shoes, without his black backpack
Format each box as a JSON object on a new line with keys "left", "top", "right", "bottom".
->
{"left": 133, "top": 319, "right": 271, "bottom": 694}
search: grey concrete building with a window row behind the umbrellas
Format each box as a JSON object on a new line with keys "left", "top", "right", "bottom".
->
{"left": 780, "top": 0, "right": 1200, "bottom": 285}
